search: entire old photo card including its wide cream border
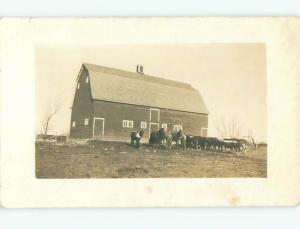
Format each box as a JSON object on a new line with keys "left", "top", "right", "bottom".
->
{"left": 0, "top": 17, "right": 300, "bottom": 208}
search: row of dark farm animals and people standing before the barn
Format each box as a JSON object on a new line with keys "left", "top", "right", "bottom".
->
{"left": 131, "top": 128, "right": 247, "bottom": 153}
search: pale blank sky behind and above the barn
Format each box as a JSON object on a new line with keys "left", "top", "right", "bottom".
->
{"left": 35, "top": 43, "right": 267, "bottom": 141}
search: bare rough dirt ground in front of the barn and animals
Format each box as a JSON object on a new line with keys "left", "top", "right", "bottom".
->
{"left": 36, "top": 142, "right": 267, "bottom": 178}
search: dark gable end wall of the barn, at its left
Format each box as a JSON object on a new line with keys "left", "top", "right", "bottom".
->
{"left": 70, "top": 67, "right": 94, "bottom": 138}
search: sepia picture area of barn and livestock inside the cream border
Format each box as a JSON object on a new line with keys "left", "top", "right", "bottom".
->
{"left": 35, "top": 43, "right": 268, "bottom": 178}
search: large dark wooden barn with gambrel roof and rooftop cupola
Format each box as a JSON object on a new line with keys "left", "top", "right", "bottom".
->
{"left": 70, "top": 63, "right": 208, "bottom": 141}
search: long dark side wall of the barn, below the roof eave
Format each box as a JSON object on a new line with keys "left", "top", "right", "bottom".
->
{"left": 94, "top": 100, "right": 208, "bottom": 141}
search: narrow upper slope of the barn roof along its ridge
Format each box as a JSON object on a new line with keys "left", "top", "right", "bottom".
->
{"left": 83, "top": 63, "right": 196, "bottom": 90}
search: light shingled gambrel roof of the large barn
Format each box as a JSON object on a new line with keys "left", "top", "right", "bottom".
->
{"left": 84, "top": 63, "right": 208, "bottom": 114}
